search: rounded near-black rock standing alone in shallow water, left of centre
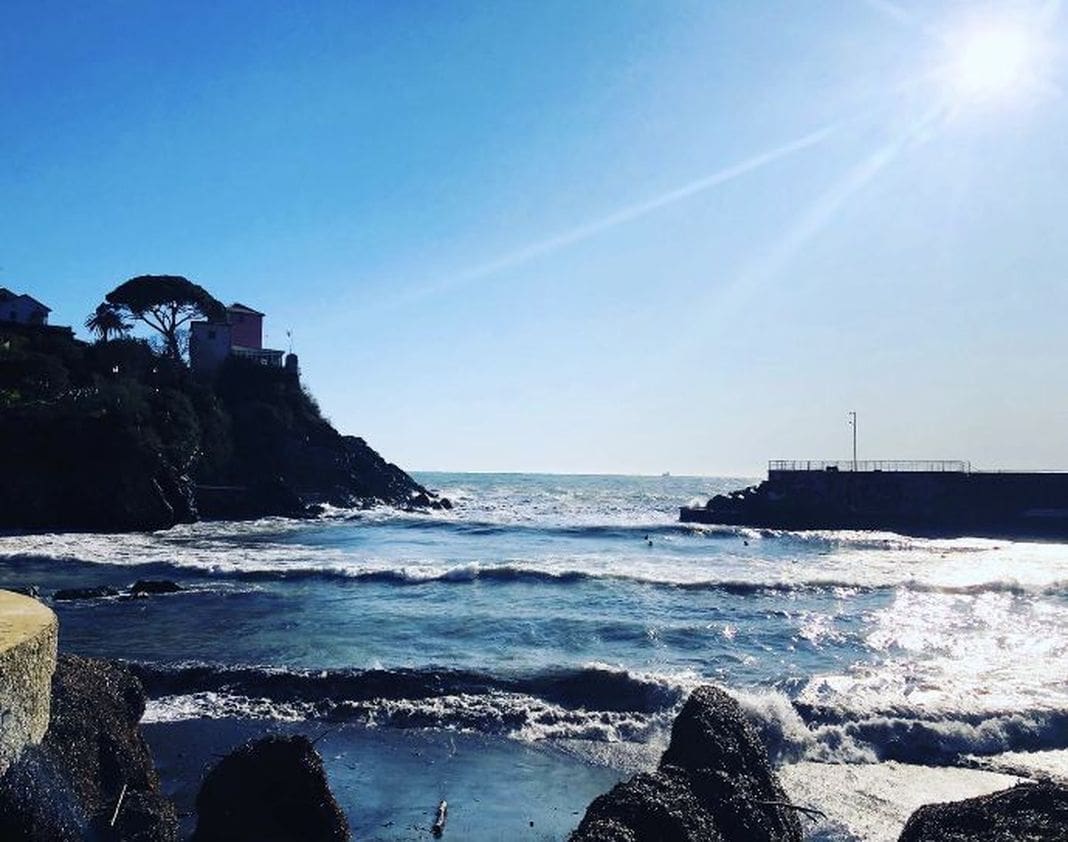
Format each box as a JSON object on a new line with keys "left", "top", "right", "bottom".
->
{"left": 192, "top": 736, "right": 349, "bottom": 842}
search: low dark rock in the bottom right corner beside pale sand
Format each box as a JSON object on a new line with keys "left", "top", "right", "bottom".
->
{"left": 898, "top": 782, "right": 1068, "bottom": 842}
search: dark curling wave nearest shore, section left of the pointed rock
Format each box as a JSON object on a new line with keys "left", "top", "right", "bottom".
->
{"left": 130, "top": 664, "right": 688, "bottom": 743}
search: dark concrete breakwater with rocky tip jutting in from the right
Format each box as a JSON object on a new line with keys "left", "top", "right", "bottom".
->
{"left": 679, "top": 463, "right": 1068, "bottom": 539}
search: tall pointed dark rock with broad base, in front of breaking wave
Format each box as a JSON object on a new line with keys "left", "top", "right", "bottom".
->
{"left": 571, "top": 686, "right": 801, "bottom": 842}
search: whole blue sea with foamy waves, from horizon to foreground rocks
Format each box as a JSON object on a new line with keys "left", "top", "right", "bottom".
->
{"left": 0, "top": 473, "right": 1068, "bottom": 842}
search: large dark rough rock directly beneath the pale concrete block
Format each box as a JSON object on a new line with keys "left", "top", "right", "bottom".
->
{"left": 0, "top": 655, "right": 177, "bottom": 842}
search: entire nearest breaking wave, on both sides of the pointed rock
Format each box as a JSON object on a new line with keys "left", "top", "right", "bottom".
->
{"left": 131, "top": 665, "right": 1068, "bottom": 766}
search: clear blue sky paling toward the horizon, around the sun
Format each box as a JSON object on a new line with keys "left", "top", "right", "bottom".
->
{"left": 0, "top": 0, "right": 1068, "bottom": 475}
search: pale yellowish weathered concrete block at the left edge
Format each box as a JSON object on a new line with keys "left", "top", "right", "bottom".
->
{"left": 0, "top": 591, "right": 59, "bottom": 776}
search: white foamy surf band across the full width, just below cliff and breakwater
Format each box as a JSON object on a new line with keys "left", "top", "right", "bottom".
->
{"left": 0, "top": 512, "right": 1068, "bottom": 595}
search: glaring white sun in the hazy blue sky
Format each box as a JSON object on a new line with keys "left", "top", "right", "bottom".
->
{"left": 947, "top": 21, "right": 1042, "bottom": 102}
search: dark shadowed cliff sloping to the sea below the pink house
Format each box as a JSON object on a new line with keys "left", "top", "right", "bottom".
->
{"left": 0, "top": 329, "right": 431, "bottom": 531}
